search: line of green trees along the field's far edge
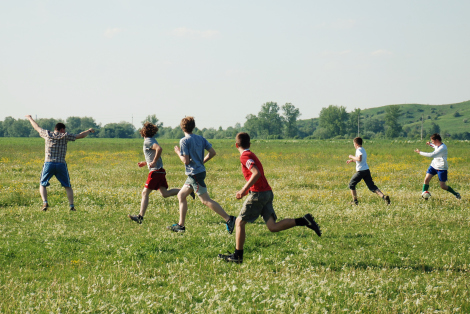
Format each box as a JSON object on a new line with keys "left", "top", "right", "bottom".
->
{"left": 0, "top": 102, "right": 470, "bottom": 140}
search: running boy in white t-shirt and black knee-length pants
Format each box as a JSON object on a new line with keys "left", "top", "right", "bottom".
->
{"left": 346, "top": 137, "right": 390, "bottom": 205}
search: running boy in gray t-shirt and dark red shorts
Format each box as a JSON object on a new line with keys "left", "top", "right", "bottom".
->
{"left": 127, "top": 122, "right": 188, "bottom": 224}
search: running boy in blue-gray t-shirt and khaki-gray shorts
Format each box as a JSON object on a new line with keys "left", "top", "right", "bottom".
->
{"left": 167, "top": 117, "right": 235, "bottom": 233}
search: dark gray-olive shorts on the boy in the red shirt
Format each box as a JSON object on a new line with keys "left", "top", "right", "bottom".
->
{"left": 239, "top": 191, "right": 277, "bottom": 222}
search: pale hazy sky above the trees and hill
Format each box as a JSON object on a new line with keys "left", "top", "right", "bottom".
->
{"left": 0, "top": 0, "right": 470, "bottom": 129}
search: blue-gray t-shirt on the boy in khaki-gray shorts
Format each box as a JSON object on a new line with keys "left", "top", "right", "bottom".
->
{"left": 180, "top": 134, "right": 212, "bottom": 175}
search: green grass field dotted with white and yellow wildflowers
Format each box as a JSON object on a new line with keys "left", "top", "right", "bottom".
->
{"left": 0, "top": 138, "right": 470, "bottom": 313}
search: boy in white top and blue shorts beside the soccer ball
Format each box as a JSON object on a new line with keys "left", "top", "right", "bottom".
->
{"left": 415, "top": 133, "right": 461, "bottom": 199}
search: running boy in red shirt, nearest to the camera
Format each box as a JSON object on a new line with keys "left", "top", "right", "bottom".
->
{"left": 218, "top": 132, "right": 321, "bottom": 263}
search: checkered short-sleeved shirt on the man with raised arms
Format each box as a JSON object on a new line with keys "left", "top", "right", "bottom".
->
{"left": 39, "top": 129, "right": 77, "bottom": 163}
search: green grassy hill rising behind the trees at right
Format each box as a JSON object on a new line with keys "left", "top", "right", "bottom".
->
{"left": 298, "top": 100, "right": 470, "bottom": 133}
